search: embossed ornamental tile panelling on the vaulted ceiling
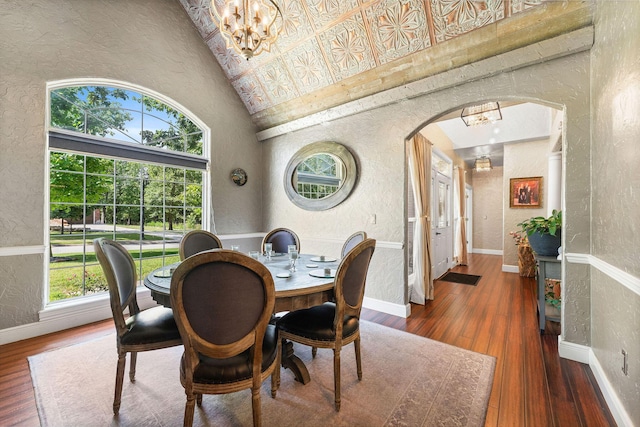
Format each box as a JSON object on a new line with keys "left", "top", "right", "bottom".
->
{"left": 179, "top": 0, "right": 560, "bottom": 128}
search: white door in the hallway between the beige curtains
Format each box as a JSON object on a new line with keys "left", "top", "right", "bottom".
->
{"left": 431, "top": 170, "right": 453, "bottom": 279}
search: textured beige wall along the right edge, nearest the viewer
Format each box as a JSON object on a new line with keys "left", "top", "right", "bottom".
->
{"left": 591, "top": 1, "right": 640, "bottom": 425}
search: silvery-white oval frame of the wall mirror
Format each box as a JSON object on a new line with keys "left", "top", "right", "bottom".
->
{"left": 284, "top": 141, "right": 358, "bottom": 211}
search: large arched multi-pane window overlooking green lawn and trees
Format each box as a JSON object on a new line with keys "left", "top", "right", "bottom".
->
{"left": 48, "top": 84, "right": 210, "bottom": 302}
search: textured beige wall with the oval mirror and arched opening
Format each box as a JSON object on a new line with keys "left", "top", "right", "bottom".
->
{"left": 264, "top": 53, "right": 589, "bottom": 310}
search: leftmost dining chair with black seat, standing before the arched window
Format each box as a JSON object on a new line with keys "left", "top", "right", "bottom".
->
{"left": 93, "top": 238, "right": 182, "bottom": 415}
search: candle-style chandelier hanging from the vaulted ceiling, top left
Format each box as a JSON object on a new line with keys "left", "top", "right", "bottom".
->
{"left": 211, "top": 0, "right": 282, "bottom": 60}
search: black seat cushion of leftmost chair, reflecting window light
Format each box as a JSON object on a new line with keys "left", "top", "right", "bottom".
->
{"left": 120, "top": 307, "right": 180, "bottom": 345}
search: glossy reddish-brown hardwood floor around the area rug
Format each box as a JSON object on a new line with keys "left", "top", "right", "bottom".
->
{"left": 0, "top": 254, "right": 615, "bottom": 427}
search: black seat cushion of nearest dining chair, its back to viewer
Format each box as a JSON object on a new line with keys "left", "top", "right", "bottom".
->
{"left": 180, "top": 325, "right": 278, "bottom": 384}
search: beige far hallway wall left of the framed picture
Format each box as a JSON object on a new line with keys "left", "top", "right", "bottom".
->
{"left": 472, "top": 166, "right": 504, "bottom": 251}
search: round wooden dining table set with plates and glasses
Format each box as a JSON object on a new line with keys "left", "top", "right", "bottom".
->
{"left": 143, "top": 253, "right": 340, "bottom": 384}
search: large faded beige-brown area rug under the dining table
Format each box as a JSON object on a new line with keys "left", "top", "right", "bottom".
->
{"left": 29, "top": 321, "right": 495, "bottom": 427}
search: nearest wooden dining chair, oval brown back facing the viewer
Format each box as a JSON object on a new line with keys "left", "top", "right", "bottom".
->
{"left": 170, "top": 249, "right": 281, "bottom": 426}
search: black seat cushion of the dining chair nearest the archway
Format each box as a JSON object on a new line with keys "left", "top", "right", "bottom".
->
{"left": 277, "top": 302, "right": 359, "bottom": 341}
